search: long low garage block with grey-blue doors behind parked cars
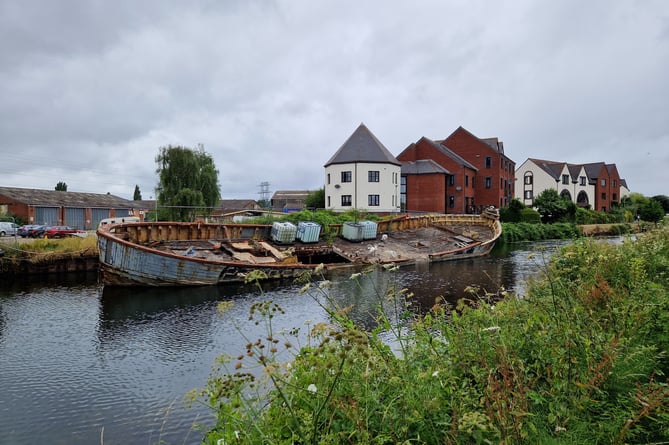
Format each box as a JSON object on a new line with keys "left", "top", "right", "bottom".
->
{"left": 0, "top": 187, "right": 135, "bottom": 230}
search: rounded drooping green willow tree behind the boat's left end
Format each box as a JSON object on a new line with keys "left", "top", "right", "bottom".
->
{"left": 156, "top": 145, "right": 221, "bottom": 221}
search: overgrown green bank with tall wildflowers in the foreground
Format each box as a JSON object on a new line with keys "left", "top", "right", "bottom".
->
{"left": 197, "top": 230, "right": 669, "bottom": 444}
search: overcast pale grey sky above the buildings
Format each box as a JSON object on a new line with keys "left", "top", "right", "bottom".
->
{"left": 0, "top": 0, "right": 669, "bottom": 199}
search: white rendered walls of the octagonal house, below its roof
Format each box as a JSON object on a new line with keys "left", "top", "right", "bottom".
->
{"left": 325, "top": 162, "right": 401, "bottom": 213}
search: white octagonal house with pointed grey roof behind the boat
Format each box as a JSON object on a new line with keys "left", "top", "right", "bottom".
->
{"left": 324, "top": 124, "right": 402, "bottom": 213}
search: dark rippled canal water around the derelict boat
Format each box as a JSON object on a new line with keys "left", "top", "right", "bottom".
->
{"left": 0, "top": 242, "right": 560, "bottom": 445}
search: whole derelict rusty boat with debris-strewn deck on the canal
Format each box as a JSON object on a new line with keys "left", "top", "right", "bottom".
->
{"left": 97, "top": 208, "right": 502, "bottom": 286}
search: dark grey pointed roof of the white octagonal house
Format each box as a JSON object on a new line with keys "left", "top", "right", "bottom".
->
{"left": 324, "top": 124, "right": 402, "bottom": 167}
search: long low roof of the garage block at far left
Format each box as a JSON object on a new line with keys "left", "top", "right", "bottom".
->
{"left": 0, "top": 187, "right": 138, "bottom": 209}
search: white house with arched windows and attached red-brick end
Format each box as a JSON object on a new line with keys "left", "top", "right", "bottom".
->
{"left": 516, "top": 158, "right": 629, "bottom": 212}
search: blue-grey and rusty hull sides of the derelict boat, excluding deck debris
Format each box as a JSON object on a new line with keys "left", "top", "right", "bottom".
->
{"left": 98, "top": 215, "right": 501, "bottom": 286}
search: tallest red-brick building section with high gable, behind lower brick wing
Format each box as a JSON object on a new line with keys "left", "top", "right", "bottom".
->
{"left": 441, "top": 126, "right": 516, "bottom": 209}
